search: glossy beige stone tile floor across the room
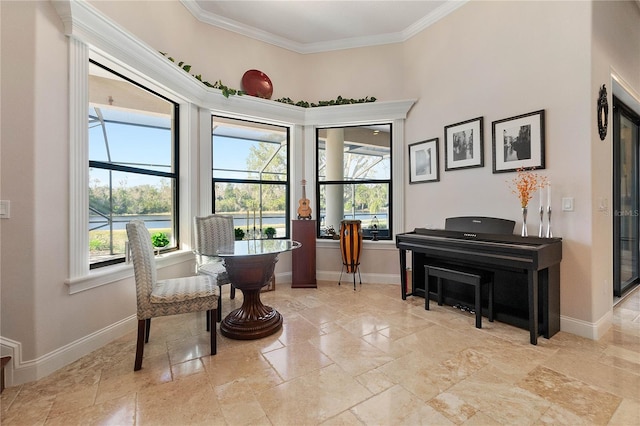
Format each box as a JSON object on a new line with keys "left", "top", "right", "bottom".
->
{"left": 1, "top": 282, "right": 640, "bottom": 426}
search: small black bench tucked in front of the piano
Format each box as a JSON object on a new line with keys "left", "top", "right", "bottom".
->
{"left": 424, "top": 265, "right": 493, "bottom": 328}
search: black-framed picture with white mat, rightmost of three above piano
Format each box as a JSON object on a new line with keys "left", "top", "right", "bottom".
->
{"left": 491, "top": 110, "right": 544, "bottom": 173}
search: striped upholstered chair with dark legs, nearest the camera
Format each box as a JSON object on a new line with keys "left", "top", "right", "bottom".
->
{"left": 127, "top": 220, "right": 220, "bottom": 371}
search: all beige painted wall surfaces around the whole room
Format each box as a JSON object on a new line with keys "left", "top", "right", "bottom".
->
{"left": 0, "top": 1, "right": 640, "bottom": 382}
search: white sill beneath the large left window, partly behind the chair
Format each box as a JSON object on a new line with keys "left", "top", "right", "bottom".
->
{"left": 65, "top": 250, "right": 194, "bottom": 294}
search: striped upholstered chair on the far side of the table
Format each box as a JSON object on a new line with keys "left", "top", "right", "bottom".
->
{"left": 193, "top": 214, "right": 236, "bottom": 322}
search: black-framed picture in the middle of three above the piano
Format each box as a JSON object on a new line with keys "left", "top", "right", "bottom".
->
{"left": 444, "top": 117, "right": 484, "bottom": 170}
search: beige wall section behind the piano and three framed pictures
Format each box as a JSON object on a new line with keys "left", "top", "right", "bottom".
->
{"left": 405, "top": 2, "right": 596, "bottom": 321}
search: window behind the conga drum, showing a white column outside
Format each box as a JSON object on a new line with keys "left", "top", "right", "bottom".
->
{"left": 316, "top": 124, "right": 392, "bottom": 240}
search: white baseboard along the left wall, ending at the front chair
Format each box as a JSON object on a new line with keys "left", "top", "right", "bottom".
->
{"left": 0, "top": 315, "right": 137, "bottom": 386}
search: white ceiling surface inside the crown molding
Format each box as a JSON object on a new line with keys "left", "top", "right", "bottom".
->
{"left": 180, "top": 0, "right": 468, "bottom": 53}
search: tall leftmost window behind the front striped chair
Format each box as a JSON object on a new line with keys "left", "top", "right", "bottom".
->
{"left": 88, "top": 61, "right": 178, "bottom": 269}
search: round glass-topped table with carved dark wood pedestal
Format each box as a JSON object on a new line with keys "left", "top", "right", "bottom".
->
{"left": 218, "top": 239, "right": 302, "bottom": 340}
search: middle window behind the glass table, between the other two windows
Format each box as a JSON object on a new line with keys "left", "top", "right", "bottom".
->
{"left": 212, "top": 116, "right": 289, "bottom": 239}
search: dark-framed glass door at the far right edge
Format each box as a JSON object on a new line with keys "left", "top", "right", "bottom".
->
{"left": 613, "top": 97, "right": 640, "bottom": 297}
